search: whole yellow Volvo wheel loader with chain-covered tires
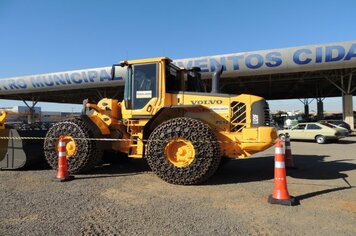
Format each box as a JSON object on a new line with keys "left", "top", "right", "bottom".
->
{"left": 44, "top": 57, "right": 277, "bottom": 185}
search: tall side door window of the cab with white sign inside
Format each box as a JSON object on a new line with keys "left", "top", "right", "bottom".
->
{"left": 132, "top": 63, "right": 158, "bottom": 109}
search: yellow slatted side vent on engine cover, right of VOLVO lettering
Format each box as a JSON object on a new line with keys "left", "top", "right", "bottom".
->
{"left": 231, "top": 102, "right": 246, "bottom": 132}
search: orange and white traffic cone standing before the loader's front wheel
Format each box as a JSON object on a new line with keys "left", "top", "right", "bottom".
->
{"left": 55, "top": 136, "right": 74, "bottom": 182}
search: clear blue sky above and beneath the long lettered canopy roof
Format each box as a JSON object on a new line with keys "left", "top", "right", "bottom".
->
{"left": 0, "top": 0, "right": 356, "bottom": 111}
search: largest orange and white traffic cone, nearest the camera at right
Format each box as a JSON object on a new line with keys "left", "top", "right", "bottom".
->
{"left": 268, "top": 139, "right": 297, "bottom": 206}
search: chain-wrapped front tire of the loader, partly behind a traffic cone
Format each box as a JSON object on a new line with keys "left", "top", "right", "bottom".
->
{"left": 44, "top": 118, "right": 102, "bottom": 174}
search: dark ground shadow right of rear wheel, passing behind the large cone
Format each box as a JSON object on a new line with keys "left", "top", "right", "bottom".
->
{"left": 205, "top": 155, "right": 356, "bottom": 185}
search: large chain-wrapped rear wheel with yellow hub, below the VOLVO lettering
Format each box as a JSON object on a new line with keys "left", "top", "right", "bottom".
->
{"left": 146, "top": 117, "right": 221, "bottom": 185}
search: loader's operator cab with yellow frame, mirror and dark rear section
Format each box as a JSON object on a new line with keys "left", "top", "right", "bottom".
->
{"left": 111, "top": 58, "right": 206, "bottom": 110}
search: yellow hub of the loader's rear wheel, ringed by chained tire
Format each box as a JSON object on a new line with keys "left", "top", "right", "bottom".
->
{"left": 164, "top": 138, "right": 195, "bottom": 167}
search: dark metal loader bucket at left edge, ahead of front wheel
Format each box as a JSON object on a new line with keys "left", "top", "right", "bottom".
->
{"left": 0, "top": 129, "right": 46, "bottom": 170}
